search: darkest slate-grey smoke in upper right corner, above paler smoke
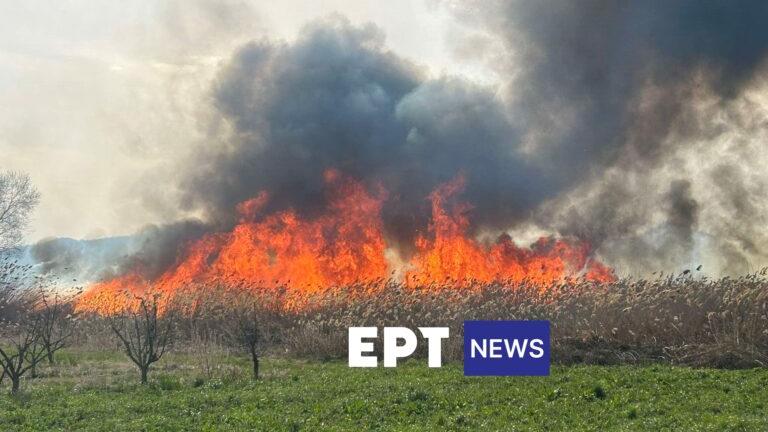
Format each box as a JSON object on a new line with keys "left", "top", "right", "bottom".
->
{"left": 464, "top": 0, "right": 768, "bottom": 172}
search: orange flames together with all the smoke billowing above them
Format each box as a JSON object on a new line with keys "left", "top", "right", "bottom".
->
{"left": 39, "top": 2, "right": 768, "bottom": 320}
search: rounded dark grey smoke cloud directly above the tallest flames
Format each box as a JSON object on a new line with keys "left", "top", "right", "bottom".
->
{"left": 176, "top": 17, "right": 553, "bottom": 245}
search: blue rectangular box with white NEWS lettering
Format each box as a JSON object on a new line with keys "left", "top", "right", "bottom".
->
{"left": 464, "top": 321, "right": 550, "bottom": 376}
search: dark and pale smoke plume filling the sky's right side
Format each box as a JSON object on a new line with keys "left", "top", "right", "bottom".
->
{"left": 440, "top": 0, "right": 768, "bottom": 275}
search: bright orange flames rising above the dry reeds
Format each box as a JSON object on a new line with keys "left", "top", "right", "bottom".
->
{"left": 77, "top": 170, "right": 614, "bottom": 314}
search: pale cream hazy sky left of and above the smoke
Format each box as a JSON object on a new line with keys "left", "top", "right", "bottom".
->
{"left": 0, "top": 0, "right": 493, "bottom": 241}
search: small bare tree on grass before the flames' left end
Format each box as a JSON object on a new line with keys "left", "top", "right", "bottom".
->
{"left": 108, "top": 294, "right": 174, "bottom": 384}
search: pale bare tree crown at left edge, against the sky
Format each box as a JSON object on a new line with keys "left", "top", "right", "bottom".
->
{"left": 0, "top": 171, "right": 40, "bottom": 251}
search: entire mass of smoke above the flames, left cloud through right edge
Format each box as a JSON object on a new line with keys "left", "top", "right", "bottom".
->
{"left": 162, "top": 0, "right": 768, "bottom": 274}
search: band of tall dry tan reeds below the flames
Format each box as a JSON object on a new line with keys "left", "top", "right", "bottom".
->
{"left": 73, "top": 271, "right": 768, "bottom": 367}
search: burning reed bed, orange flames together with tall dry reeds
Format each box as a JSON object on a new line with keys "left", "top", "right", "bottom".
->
{"left": 67, "top": 169, "right": 768, "bottom": 368}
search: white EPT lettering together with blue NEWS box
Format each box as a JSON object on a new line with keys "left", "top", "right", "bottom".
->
{"left": 348, "top": 321, "right": 550, "bottom": 376}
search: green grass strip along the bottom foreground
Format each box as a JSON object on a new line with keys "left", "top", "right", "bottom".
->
{"left": 0, "top": 353, "right": 768, "bottom": 431}
